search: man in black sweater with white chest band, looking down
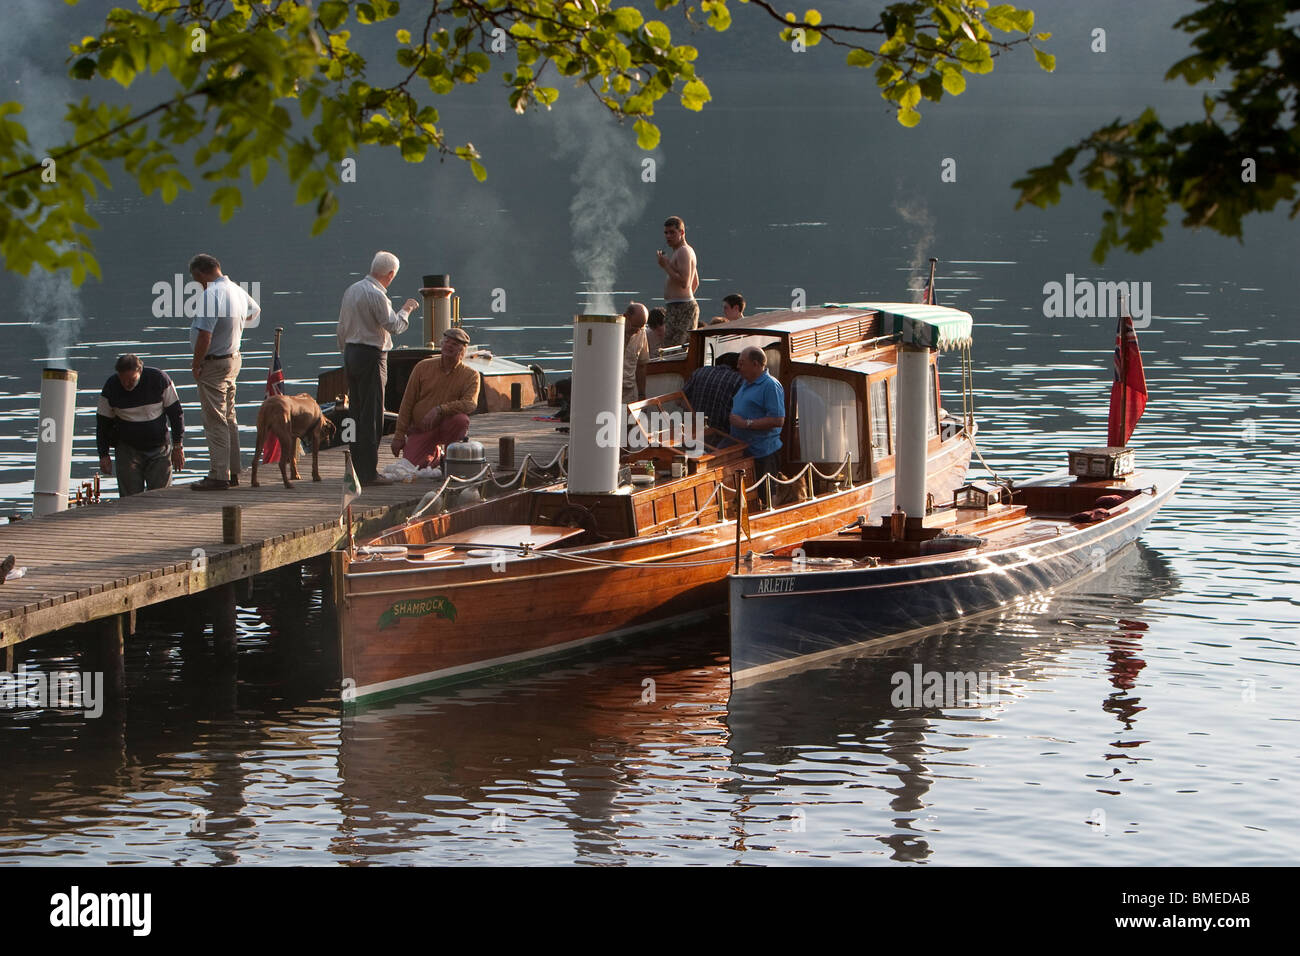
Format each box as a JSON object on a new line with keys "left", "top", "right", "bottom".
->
{"left": 95, "top": 354, "right": 185, "bottom": 498}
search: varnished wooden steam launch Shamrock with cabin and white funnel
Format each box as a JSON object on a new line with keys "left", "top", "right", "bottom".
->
{"left": 335, "top": 303, "right": 971, "bottom": 702}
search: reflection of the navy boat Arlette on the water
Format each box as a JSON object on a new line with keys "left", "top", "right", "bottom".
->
{"left": 727, "top": 542, "right": 1178, "bottom": 862}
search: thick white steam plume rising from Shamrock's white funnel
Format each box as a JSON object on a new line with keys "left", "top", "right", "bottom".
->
{"left": 558, "top": 96, "right": 649, "bottom": 315}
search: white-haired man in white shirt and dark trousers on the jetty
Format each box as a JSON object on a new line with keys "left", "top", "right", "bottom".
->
{"left": 338, "top": 251, "right": 423, "bottom": 485}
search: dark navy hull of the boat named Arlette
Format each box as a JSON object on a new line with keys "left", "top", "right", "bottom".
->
{"left": 728, "top": 471, "right": 1184, "bottom": 685}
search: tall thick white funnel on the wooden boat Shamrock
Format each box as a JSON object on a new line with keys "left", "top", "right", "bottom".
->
{"left": 568, "top": 315, "right": 624, "bottom": 494}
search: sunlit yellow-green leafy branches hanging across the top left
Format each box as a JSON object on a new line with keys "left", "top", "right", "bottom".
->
{"left": 0, "top": 0, "right": 1053, "bottom": 284}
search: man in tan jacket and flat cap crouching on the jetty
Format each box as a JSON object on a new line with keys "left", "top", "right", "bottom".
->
{"left": 393, "top": 328, "right": 478, "bottom": 468}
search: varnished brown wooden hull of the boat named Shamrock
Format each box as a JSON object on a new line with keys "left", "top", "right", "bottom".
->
{"left": 339, "top": 440, "right": 970, "bottom": 704}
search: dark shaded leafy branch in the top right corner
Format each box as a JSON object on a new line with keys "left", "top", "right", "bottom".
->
{"left": 1014, "top": 0, "right": 1300, "bottom": 263}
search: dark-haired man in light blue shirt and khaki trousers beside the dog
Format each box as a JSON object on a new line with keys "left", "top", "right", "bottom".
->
{"left": 190, "top": 252, "right": 261, "bottom": 492}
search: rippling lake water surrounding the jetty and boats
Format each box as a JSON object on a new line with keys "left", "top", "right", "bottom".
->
{"left": 0, "top": 3, "right": 1300, "bottom": 866}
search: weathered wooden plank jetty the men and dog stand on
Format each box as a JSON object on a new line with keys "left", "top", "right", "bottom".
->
{"left": 0, "top": 406, "right": 568, "bottom": 648}
